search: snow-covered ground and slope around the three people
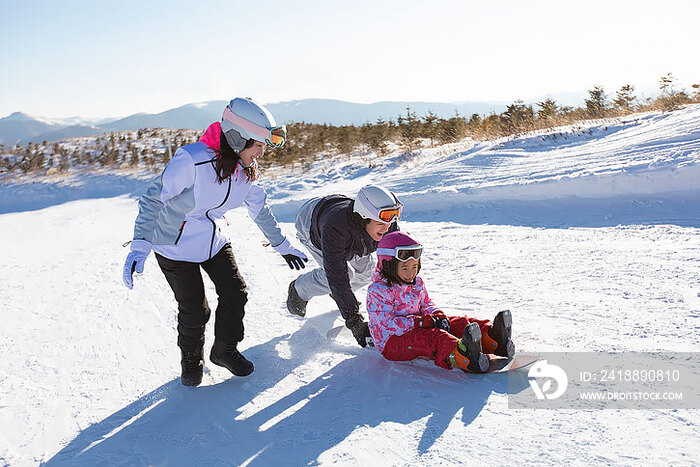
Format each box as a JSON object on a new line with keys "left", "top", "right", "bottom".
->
{"left": 0, "top": 106, "right": 700, "bottom": 466}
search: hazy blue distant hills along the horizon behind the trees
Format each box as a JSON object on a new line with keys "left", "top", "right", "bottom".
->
{"left": 0, "top": 99, "right": 506, "bottom": 145}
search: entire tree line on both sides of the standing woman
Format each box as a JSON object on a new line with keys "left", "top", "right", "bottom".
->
{"left": 0, "top": 73, "right": 700, "bottom": 175}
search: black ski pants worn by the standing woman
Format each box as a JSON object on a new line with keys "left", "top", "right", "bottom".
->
{"left": 156, "top": 243, "right": 248, "bottom": 352}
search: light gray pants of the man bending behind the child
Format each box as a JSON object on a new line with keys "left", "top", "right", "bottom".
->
{"left": 294, "top": 199, "right": 376, "bottom": 302}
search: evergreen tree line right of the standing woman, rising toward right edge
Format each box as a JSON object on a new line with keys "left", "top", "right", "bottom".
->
{"left": 262, "top": 73, "right": 700, "bottom": 165}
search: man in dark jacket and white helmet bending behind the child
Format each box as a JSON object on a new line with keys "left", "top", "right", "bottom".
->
{"left": 287, "top": 185, "right": 403, "bottom": 347}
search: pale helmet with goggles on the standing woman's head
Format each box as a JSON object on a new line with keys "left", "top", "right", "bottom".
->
{"left": 221, "top": 97, "right": 287, "bottom": 152}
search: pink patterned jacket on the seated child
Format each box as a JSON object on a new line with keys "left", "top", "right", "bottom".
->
{"left": 367, "top": 268, "right": 439, "bottom": 352}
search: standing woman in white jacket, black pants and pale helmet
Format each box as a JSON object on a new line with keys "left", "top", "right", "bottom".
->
{"left": 123, "top": 97, "right": 308, "bottom": 386}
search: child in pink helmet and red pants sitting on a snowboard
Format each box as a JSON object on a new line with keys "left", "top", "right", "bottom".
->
{"left": 367, "top": 232, "right": 515, "bottom": 373}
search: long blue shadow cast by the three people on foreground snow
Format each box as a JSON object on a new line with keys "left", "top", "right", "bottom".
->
{"left": 46, "top": 313, "right": 527, "bottom": 466}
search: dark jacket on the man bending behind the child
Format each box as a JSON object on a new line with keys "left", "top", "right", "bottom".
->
{"left": 309, "top": 195, "right": 399, "bottom": 319}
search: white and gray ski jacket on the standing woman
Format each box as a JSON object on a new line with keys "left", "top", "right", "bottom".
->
{"left": 134, "top": 130, "right": 285, "bottom": 263}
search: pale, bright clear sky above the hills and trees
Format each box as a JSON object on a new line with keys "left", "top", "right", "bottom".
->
{"left": 0, "top": 0, "right": 700, "bottom": 117}
